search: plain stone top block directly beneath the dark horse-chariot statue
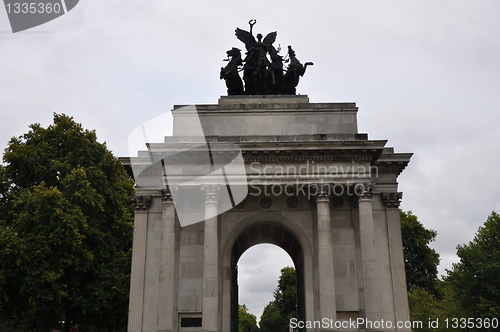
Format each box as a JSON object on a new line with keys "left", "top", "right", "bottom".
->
{"left": 172, "top": 96, "right": 358, "bottom": 136}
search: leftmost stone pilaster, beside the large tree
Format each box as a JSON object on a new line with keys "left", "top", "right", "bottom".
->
{"left": 128, "top": 196, "right": 151, "bottom": 332}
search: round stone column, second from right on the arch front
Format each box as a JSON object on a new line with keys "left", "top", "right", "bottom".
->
{"left": 355, "top": 182, "right": 383, "bottom": 328}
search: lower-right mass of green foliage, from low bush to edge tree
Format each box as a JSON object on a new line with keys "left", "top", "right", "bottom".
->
{"left": 407, "top": 212, "right": 500, "bottom": 332}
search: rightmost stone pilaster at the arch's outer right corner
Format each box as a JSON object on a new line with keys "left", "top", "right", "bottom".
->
{"left": 382, "top": 192, "right": 411, "bottom": 331}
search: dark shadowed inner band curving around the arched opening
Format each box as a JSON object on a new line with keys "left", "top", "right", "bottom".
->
{"left": 230, "top": 221, "right": 306, "bottom": 331}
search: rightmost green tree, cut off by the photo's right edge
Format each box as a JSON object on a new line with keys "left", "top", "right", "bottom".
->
{"left": 447, "top": 211, "right": 500, "bottom": 318}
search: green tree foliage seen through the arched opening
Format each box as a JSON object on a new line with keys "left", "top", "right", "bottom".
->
{"left": 259, "top": 266, "right": 297, "bottom": 332}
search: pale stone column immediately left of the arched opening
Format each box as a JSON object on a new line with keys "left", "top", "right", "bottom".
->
{"left": 200, "top": 185, "right": 221, "bottom": 332}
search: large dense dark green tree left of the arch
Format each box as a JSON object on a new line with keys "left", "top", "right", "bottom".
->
{"left": 0, "top": 114, "right": 133, "bottom": 332}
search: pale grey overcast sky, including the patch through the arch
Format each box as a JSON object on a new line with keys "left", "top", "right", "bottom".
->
{"left": 0, "top": 0, "right": 500, "bottom": 322}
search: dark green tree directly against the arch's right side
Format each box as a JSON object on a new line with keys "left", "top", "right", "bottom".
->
{"left": 400, "top": 210, "right": 439, "bottom": 295}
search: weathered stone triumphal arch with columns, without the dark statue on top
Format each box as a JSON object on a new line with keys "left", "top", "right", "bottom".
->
{"left": 122, "top": 96, "right": 411, "bottom": 332}
